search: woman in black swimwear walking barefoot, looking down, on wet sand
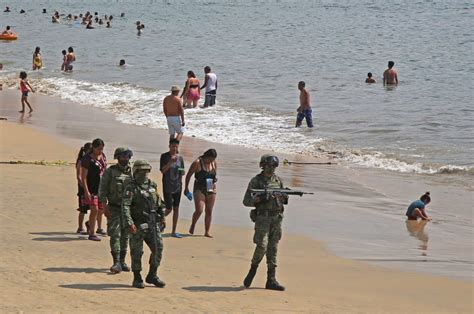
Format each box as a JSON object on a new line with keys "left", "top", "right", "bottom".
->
{"left": 184, "top": 148, "right": 217, "bottom": 238}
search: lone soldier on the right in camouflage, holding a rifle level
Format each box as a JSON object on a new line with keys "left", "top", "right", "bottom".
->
{"left": 243, "top": 155, "right": 288, "bottom": 291}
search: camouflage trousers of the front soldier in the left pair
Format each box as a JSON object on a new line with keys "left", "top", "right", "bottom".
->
{"left": 130, "top": 228, "right": 163, "bottom": 271}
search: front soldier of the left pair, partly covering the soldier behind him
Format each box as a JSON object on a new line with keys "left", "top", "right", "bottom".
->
{"left": 122, "top": 160, "right": 165, "bottom": 289}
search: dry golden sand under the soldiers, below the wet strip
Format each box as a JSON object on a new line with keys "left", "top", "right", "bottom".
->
{"left": 0, "top": 121, "right": 473, "bottom": 313}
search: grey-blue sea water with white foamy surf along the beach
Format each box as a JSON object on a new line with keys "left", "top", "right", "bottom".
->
{"left": 0, "top": 0, "right": 474, "bottom": 177}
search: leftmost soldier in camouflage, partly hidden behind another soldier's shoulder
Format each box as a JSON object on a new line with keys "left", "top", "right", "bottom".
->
{"left": 99, "top": 147, "right": 133, "bottom": 274}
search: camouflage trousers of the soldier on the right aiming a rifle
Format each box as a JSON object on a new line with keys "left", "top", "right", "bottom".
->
{"left": 252, "top": 214, "right": 283, "bottom": 268}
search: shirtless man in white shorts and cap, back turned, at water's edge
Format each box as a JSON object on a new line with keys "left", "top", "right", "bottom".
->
{"left": 163, "top": 85, "right": 184, "bottom": 141}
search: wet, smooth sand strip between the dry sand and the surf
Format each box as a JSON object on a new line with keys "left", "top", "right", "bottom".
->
{"left": 0, "top": 91, "right": 473, "bottom": 280}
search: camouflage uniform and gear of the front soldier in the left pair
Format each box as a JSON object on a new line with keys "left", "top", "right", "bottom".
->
{"left": 122, "top": 161, "right": 165, "bottom": 288}
